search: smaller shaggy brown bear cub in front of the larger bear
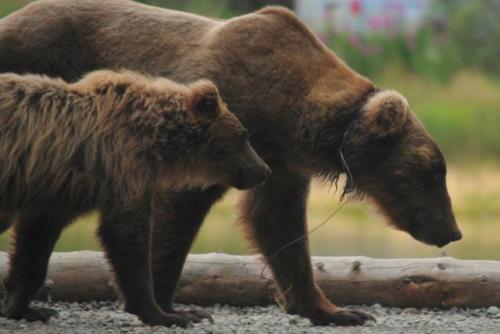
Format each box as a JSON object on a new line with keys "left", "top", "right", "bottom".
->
{"left": 0, "top": 71, "right": 269, "bottom": 327}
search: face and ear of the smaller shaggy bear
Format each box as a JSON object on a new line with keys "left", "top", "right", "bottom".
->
{"left": 188, "top": 81, "right": 271, "bottom": 189}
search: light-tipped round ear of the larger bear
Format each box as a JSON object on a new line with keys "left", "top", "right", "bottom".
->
{"left": 363, "top": 91, "right": 410, "bottom": 137}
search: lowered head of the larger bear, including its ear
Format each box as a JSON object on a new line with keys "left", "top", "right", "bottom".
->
{"left": 348, "top": 92, "right": 461, "bottom": 247}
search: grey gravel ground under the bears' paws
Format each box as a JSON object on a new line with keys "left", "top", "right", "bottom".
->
{"left": 0, "top": 302, "right": 500, "bottom": 334}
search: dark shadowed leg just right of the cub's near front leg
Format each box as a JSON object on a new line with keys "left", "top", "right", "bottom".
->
{"left": 152, "top": 186, "right": 225, "bottom": 322}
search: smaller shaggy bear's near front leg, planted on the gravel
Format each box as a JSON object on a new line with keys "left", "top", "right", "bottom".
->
{"left": 98, "top": 201, "right": 191, "bottom": 327}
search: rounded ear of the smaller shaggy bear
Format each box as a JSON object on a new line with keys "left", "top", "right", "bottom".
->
{"left": 191, "top": 80, "right": 220, "bottom": 122}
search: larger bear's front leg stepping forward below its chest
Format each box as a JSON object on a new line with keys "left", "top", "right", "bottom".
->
{"left": 241, "top": 168, "right": 373, "bottom": 326}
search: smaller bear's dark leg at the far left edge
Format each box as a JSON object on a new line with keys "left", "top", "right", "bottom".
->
{"left": 0, "top": 214, "right": 66, "bottom": 322}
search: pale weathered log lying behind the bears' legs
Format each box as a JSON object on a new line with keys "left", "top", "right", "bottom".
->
{"left": 0, "top": 251, "right": 500, "bottom": 308}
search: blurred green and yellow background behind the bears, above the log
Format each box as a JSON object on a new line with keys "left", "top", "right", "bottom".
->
{"left": 0, "top": 0, "right": 500, "bottom": 260}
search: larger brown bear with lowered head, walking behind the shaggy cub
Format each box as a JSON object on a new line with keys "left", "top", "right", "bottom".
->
{"left": 0, "top": 0, "right": 461, "bottom": 325}
